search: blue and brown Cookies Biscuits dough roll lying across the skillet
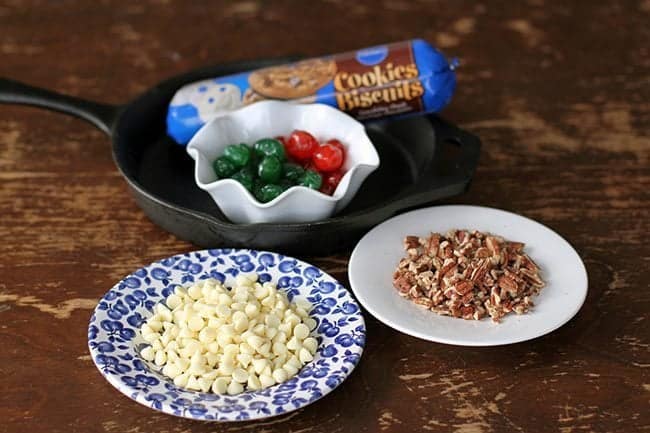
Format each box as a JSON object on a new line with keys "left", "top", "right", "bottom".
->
{"left": 167, "top": 39, "right": 457, "bottom": 145}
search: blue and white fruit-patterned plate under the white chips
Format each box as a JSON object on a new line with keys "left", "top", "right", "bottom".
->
{"left": 88, "top": 249, "right": 366, "bottom": 421}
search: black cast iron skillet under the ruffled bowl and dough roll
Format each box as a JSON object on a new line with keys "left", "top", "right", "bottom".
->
{"left": 0, "top": 59, "right": 480, "bottom": 255}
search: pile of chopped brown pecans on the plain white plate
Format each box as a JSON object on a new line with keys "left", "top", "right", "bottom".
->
{"left": 393, "top": 230, "right": 544, "bottom": 322}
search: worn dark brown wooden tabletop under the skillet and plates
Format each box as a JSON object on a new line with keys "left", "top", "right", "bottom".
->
{"left": 0, "top": 0, "right": 650, "bottom": 433}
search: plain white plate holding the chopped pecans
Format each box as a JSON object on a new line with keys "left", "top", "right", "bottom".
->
{"left": 348, "top": 206, "right": 587, "bottom": 346}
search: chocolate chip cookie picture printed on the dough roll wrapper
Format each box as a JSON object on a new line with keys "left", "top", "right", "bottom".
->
{"left": 248, "top": 59, "right": 336, "bottom": 99}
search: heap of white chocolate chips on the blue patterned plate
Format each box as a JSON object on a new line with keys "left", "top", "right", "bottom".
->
{"left": 140, "top": 274, "right": 318, "bottom": 395}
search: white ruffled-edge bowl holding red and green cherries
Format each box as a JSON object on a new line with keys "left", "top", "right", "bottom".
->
{"left": 187, "top": 101, "right": 379, "bottom": 223}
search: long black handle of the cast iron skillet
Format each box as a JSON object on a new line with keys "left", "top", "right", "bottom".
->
{"left": 0, "top": 78, "right": 120, "bottom": 135}
